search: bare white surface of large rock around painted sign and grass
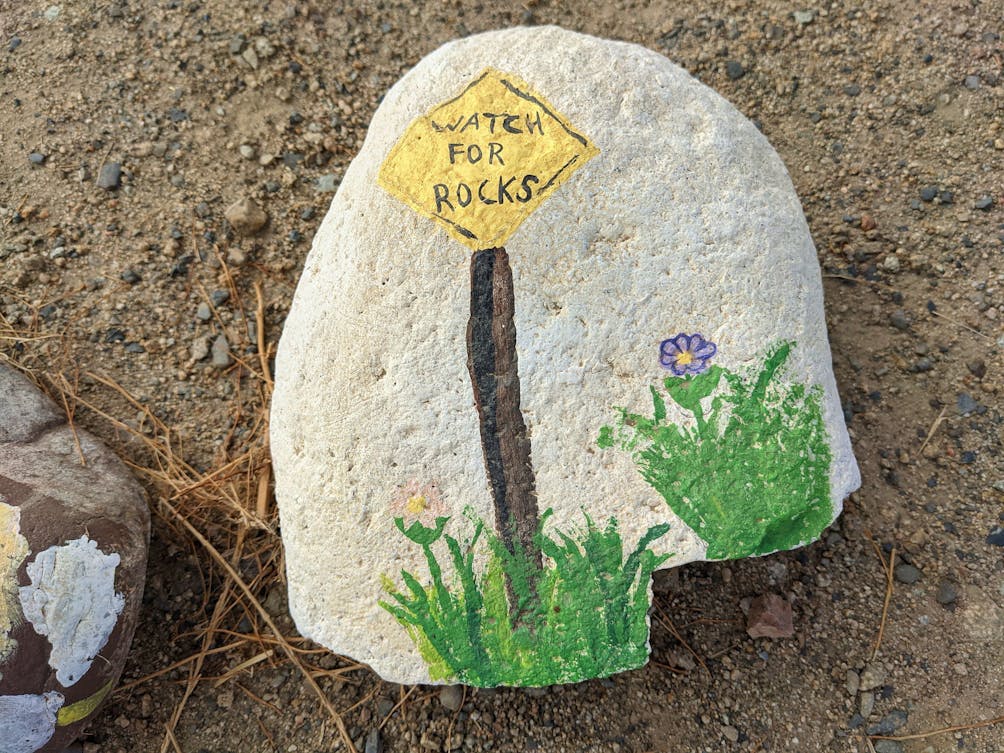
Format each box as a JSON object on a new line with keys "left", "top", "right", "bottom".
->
{"left": 271, "top": 27, "right": 859, "bottom": 683}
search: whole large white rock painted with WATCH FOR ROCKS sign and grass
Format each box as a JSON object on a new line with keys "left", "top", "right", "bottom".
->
{"left": 271, "top": 27, "right": 859, "bottom": 686}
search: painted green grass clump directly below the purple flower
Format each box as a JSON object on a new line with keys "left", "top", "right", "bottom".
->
{"left": 598, "top": 342, "right": 832, "bottom": 559}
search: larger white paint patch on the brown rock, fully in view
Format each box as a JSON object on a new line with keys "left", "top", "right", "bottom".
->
{"left": 20, "top": 535, "right": 126, "bottom": 688}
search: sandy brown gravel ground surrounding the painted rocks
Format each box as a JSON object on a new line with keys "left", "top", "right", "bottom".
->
{"left": 0, "top": 0, "right": 1004, "bottom": 753}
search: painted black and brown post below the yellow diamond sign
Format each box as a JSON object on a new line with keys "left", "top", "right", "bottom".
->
{"left": 467, "top": 248, "right": 542, "bottom": 616}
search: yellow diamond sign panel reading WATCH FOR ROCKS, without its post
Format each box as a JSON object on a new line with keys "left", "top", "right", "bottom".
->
{"left": 378, "top": 68, "right": 599, "bottom": 250}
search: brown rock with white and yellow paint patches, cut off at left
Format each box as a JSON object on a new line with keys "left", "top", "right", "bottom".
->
{"left": 0, "top": 365, "right": 150, "bottom": 753}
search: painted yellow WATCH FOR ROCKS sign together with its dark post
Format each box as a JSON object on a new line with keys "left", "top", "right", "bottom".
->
{"left": 379, "top": 68, "right": 598, "bottom": 619}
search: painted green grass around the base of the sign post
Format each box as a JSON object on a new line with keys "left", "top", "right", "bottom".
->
{"left": 380, "top": 510, "right": 670, "bottom": 687}
